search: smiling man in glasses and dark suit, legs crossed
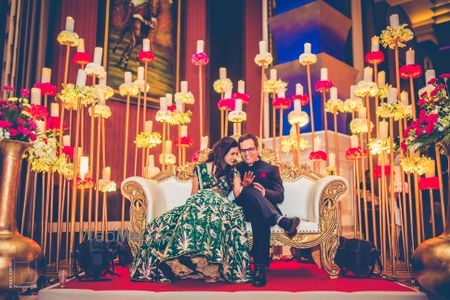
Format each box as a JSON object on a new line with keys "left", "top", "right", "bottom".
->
{"left": 235, "top": 134, "right": 300, "bottom": 287}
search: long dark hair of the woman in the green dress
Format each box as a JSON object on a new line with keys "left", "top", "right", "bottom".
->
{"left": 206, "top": 137, "right": 239, "bottom": 180}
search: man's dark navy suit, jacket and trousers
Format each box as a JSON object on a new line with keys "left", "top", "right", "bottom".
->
{"left": 235, "top": 159, "right": 284, "bottom": 264}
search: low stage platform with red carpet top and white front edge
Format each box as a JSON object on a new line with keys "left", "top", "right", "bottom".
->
{"left": 38, "top": 261, "right": 428, "bottom": 300}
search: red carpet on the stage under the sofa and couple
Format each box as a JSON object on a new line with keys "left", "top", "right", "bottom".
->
{"left": 62, "top": 261, "right": 413, "bottom": 292}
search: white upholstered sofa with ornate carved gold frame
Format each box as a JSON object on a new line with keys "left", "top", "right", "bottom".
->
{"left": 121, "top": 158, "right": 348, "bottom": 278}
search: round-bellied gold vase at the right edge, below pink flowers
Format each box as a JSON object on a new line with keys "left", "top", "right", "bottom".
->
{"left": 413, "top": 145, "right": 450, "bottom": 297}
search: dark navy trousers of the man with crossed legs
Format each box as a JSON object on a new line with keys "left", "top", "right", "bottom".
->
{"left": 235, "top": 186, "right": 280, "bottom": 264}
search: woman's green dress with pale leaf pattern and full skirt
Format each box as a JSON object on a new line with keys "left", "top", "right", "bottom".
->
{"left": 130, "top": 164, "right": 251, "bottom": 283}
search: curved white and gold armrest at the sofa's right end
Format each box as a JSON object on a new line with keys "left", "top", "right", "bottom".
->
{"left": 308, "top": 175, "right": 349, "bottom": 223}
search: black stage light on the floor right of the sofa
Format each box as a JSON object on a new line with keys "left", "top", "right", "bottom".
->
{"left": 334, "top": 237, "right": 383, "bottom": 277}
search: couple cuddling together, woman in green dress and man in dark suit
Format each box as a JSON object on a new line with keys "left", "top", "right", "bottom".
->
{"left": 131, "top": 134, "right": 300, "bottom": 287}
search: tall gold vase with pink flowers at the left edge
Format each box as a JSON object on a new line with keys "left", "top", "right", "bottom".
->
{"left": 0, "top": 141, "right": 43, "bottom": 290}
